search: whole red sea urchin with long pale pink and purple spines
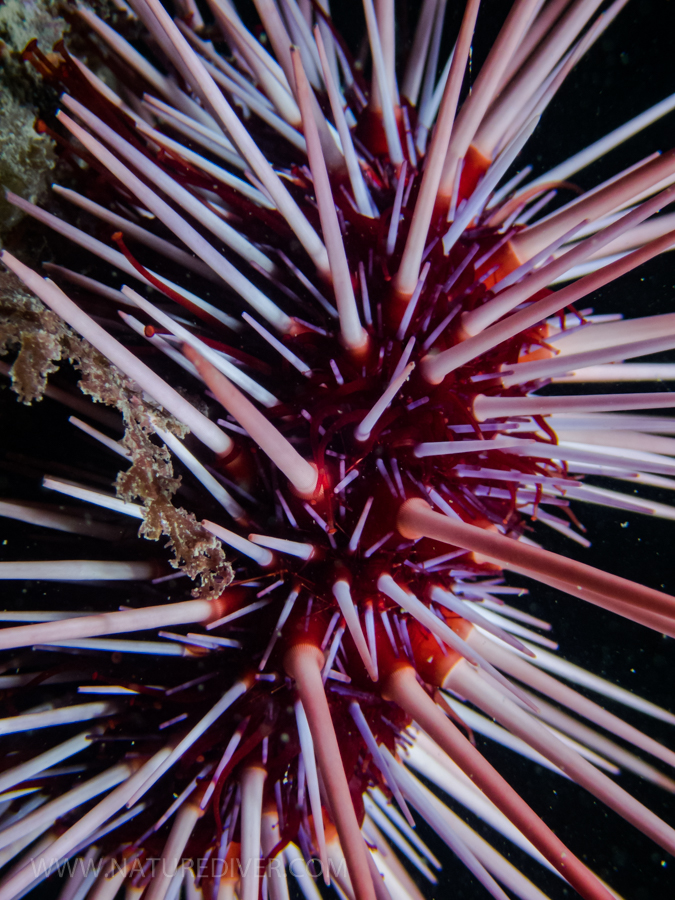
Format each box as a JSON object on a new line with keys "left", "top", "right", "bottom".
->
{"left": 0, "top": 0, "right": 675, "bottom": 900}
